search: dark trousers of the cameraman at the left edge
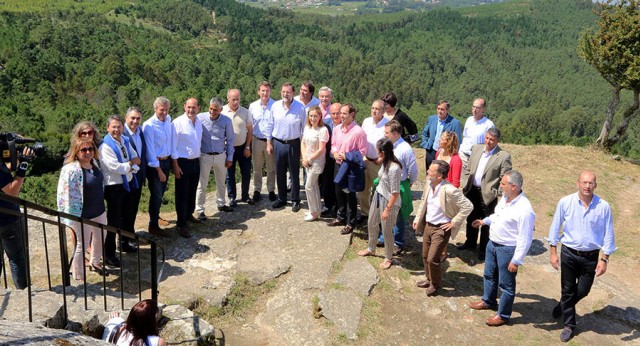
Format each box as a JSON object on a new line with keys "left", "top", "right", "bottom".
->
{"left": 0, "top": 219, "right": 27, "bottom": 290}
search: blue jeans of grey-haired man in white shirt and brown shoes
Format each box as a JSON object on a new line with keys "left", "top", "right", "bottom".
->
{"left": 482, "top": 241, "right": 517, "bottom": 320}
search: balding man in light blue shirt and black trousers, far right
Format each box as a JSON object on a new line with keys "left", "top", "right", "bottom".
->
{"left": 547, "top": 171, "right": 616, "bottom": 342}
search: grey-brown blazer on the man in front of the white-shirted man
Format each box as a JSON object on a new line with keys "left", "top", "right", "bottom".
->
{"left": 460, "top": 144, "right": 511, "bottom": 205}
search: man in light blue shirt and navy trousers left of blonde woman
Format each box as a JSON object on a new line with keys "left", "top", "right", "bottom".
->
{"left": 267, "top": 83, "right": 306, "bottom": 212}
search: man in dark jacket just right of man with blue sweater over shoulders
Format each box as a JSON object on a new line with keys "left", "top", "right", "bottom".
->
{"left": 121, "top": 107, "right": 147, "bottom": 251}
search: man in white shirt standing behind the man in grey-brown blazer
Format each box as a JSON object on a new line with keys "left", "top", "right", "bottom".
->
{"left": 458, "top": 98, "right": 495, "bottom": 171}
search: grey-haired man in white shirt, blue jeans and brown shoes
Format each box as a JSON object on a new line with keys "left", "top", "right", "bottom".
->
{"left": 469, "top": 170, "right": 536, "bottom": 327}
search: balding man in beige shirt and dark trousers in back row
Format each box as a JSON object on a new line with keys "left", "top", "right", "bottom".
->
{"left": 222, "top": 89, "right": 255, "bottom": 207}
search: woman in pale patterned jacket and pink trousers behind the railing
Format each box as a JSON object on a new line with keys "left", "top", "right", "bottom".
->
{"left": 57, "top": 138, "right": 107, "bottom": 280}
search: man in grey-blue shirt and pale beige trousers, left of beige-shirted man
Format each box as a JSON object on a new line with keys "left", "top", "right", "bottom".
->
{"left": 196, "top": 97, "right": 234, "bottom": 221}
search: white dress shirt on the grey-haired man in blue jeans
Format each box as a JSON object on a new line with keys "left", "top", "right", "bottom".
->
{"left": 482, "top": 192, "right": 536, "bottom": 265}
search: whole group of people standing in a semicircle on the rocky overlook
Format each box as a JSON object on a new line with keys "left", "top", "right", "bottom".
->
{"left": 0, "top": 81, "right": 615, "bottom": 341}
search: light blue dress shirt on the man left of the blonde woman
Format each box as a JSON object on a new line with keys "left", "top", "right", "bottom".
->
{"left": 271, "top": 100, "right": 306, "bottom": 141}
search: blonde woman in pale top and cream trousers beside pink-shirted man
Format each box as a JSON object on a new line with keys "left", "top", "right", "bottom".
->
{"left": 300, "top": 106, "right": 329, "bottom": 221}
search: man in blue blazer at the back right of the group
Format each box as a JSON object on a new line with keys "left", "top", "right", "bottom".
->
{"left": 420, "top": 100, "right": 462, "bottom": 170}
